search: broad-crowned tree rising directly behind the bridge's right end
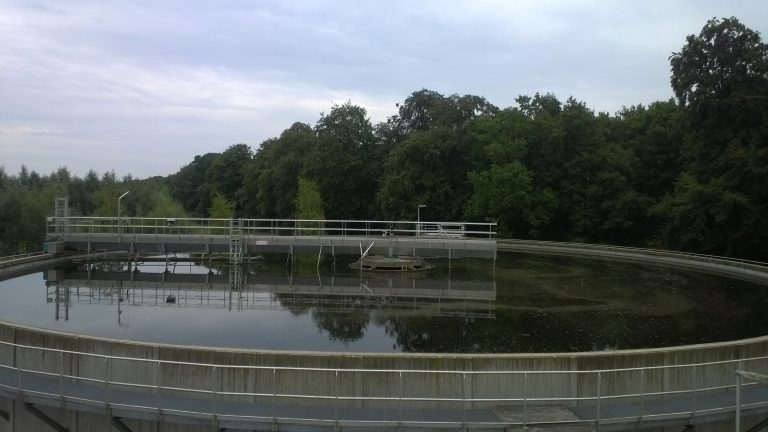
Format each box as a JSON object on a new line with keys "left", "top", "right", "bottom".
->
{"left": 376, "top": 89, "right": 498, "bottom": 220}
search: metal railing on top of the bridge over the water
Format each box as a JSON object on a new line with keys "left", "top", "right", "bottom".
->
{"left": 46, "top": 217, "right": 496, "bottom": 239}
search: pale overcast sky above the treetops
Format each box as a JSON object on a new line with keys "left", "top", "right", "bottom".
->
{"left": 0, "top": 0, "right": 768, "bottom": 178}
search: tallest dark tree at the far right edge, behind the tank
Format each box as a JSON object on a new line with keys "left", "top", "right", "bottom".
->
{"left": 654, "top": 18, "right": 768, "bottom": 259}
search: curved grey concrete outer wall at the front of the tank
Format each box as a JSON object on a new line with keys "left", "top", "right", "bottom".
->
{"left": 0, "top": 323, "right": 768, "bottom": 406}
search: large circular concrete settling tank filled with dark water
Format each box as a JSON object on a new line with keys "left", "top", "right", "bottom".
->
{"left": 0, "top": 242, "right": 768, "bottom": 431}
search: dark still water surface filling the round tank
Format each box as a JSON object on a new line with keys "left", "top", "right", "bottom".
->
{"left": 0, "top": 254, "right": 768, "bottom": 353}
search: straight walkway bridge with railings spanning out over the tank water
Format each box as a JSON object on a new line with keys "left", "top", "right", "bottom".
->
{"left": 46, "top": 216, "right": 496, "bottom": 260}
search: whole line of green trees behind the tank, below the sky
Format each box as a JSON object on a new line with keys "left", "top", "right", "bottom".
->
{"left": 0, "top": 18, "right": 768, "bottom": 260}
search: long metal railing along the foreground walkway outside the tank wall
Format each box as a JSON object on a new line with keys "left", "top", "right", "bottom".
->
{"left": 0, "top": 342, "right": 768, "bottom": 430}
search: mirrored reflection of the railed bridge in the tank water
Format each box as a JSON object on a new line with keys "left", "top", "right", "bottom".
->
{"left": 48, "top": 271, "right": 496, "bottom": 317}
